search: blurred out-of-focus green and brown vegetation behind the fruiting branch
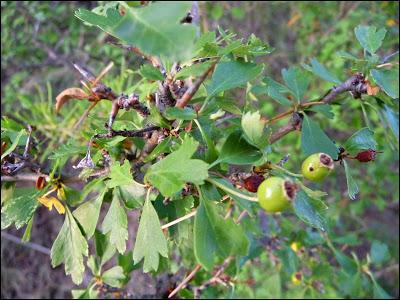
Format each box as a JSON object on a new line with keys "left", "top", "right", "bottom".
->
{"left": 1, "top": 1, "right": 399, "bottom": 298}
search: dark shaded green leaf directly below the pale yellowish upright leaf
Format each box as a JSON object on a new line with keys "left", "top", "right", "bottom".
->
{"left": 212, "top": 130, "right": 262, "bottom": 165}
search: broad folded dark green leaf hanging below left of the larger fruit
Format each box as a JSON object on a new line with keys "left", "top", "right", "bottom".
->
{"left": 193, "top": 194, "right": 249, "bottom": 271}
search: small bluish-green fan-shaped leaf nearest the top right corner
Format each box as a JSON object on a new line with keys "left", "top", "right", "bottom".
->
{"left": 354, "top": 25, "right": 386, "bottom": 54}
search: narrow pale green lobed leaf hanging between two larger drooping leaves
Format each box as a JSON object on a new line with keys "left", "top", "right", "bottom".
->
{"left": 102, "top": 189, "right": 128, "bottom": 253}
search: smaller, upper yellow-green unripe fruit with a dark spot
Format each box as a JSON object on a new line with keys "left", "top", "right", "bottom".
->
{"left": 301, "top": 153, "right": 334, "bottom": 182}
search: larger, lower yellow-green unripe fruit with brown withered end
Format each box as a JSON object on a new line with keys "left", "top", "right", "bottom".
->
{"left": 257, "top": 177, "right": 296, "bottom": 213}
